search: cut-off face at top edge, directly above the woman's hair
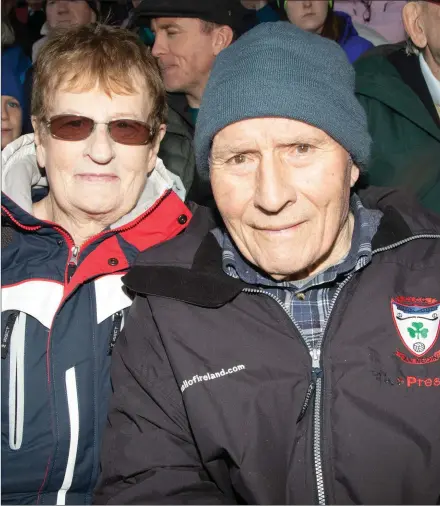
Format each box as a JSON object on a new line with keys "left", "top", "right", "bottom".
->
{"left": 46, "top": 0, "right": 96, "bottom": 28}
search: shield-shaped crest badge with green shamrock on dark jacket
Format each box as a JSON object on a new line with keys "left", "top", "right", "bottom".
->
{"left": 391, "top": 297, "right": 440, "bottom": 364}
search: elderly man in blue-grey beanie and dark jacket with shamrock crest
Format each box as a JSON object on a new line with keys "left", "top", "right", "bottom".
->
{"left": 96, "top": 22, "right": 440, "bottom": 504}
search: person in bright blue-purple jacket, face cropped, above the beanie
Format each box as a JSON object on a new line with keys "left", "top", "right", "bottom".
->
{"left": 278, "top": 0, "right": 374, "bottom": 63}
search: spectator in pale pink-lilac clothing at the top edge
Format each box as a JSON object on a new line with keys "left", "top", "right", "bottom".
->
{"left": 335, "top": 0, "right": 405, "bottom": 42}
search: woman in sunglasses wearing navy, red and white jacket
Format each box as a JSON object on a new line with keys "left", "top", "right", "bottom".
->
{"left": 2, "top": 26, "right": 190, "bottom": 504}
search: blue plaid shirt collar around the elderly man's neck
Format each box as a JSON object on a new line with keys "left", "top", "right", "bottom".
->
{"left": 218, "top": 194, "right": 383, "bottom": 292}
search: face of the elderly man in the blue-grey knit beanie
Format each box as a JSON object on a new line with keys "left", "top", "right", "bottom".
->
{"left": 211, "top": 118, "right": 359, "bottom": 280}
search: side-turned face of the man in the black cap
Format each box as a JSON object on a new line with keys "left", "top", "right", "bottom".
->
{"left": 151, "top": 18, "right": 219, "bottom": 98}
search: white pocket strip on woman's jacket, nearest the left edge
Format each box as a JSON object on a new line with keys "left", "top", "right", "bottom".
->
{"left": 9, "top": 312, "right": 26, "bottom": 450}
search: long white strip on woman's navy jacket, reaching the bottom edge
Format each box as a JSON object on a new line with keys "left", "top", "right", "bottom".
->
{"left": 57, "top": 367, "right": 79, "bottom": 504}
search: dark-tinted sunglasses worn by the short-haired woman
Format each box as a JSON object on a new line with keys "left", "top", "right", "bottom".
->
{"left": 46, "top": 114, "right": 154, "bottom": 146}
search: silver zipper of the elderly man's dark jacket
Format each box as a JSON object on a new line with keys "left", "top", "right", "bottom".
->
{"left": 243, "top": 234, "right": 440, "bottom": 505}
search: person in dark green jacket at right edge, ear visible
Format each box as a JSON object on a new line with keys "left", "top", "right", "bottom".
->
{"left": 355, "top": 1, "right": 440, "bottom": 212}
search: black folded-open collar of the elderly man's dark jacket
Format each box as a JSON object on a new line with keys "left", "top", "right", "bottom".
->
{"left": 123, "top": 188, "right": 440, "bottom": 308}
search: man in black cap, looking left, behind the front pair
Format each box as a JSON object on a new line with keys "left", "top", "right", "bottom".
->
{"left": 134, "top": 0, "right": 254, "bottom": 203}
